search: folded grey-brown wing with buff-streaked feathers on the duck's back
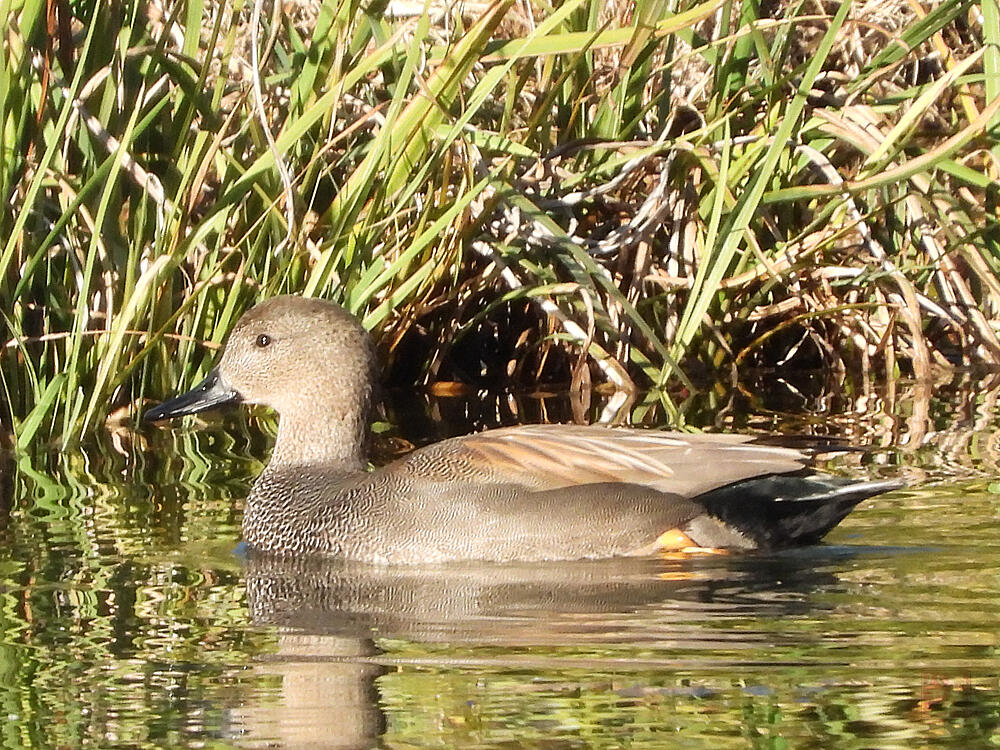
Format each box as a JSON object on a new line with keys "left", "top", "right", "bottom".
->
{"left": 401, "top": 425, "right": 810, "bottom": 497}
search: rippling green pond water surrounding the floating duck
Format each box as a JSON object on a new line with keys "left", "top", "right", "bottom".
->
{"left": 0, "top": 376, "right": 1000, "bottom": 750}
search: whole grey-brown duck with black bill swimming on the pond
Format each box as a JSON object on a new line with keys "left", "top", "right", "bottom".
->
{"left": 145, "top": 296, "right": 900, "bottom": 563}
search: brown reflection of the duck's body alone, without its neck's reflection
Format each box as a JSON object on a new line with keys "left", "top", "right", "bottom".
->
{"left": 246, "top": 548, "right": 848, "bottom": 645}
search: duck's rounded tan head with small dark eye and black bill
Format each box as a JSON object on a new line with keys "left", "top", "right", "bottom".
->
{"left": 144, "top": 296, "right": 374, "bottom": 422}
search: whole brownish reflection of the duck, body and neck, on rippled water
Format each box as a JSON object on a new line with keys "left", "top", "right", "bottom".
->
{"left": 234, "top": 547, "right": 852, "bottom": 748}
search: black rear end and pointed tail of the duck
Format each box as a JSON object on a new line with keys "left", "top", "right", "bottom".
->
{"left": 695, "top": 472, "right": 903, "bottom": 549}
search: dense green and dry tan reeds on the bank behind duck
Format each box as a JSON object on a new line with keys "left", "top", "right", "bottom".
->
{"left": 0, "top": 0, "right": 1000, "bottom": 447}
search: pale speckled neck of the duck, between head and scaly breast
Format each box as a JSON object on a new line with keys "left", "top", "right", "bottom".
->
{"left": 268, "top": 404, "right": 369, "bottom": 474}
